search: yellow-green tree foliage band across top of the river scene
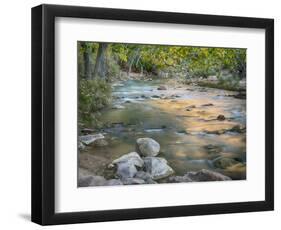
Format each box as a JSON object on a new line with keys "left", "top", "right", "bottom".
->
{"left": 78, "top": 42, "right": 246, "bottom": 79}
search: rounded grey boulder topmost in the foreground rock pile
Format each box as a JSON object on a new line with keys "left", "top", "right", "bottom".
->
{"left": 136, "top": 138, "right": 160, "bottom": 156}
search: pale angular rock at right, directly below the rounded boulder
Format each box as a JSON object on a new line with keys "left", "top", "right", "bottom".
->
{"left": 144, "top": 157, "right": 174, "bottom": 180}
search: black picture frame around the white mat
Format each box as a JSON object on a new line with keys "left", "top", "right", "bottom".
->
{"left": 31, "top": 5, "right": 274, "bottom": 225}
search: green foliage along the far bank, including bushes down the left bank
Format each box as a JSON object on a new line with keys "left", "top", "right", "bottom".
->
{"left": 77, "top": 41, "right": 246, "bottom": 127}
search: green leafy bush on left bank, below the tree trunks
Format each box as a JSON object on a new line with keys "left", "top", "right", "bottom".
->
{"left": 78, "top": 79, "right": 111, "bottom": 127}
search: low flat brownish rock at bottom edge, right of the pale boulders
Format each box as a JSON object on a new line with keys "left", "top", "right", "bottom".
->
{"left": 169, "top": 169, "right": 231, "bottom": 183}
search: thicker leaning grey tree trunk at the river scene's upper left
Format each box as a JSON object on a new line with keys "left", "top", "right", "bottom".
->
{"left": 93, "top": 43, "right": 108, "bottom": 79}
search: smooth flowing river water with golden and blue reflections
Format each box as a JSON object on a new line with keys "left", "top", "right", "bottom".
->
{"left": 80, "top": 80, "right": 246, "bottom": 180}
